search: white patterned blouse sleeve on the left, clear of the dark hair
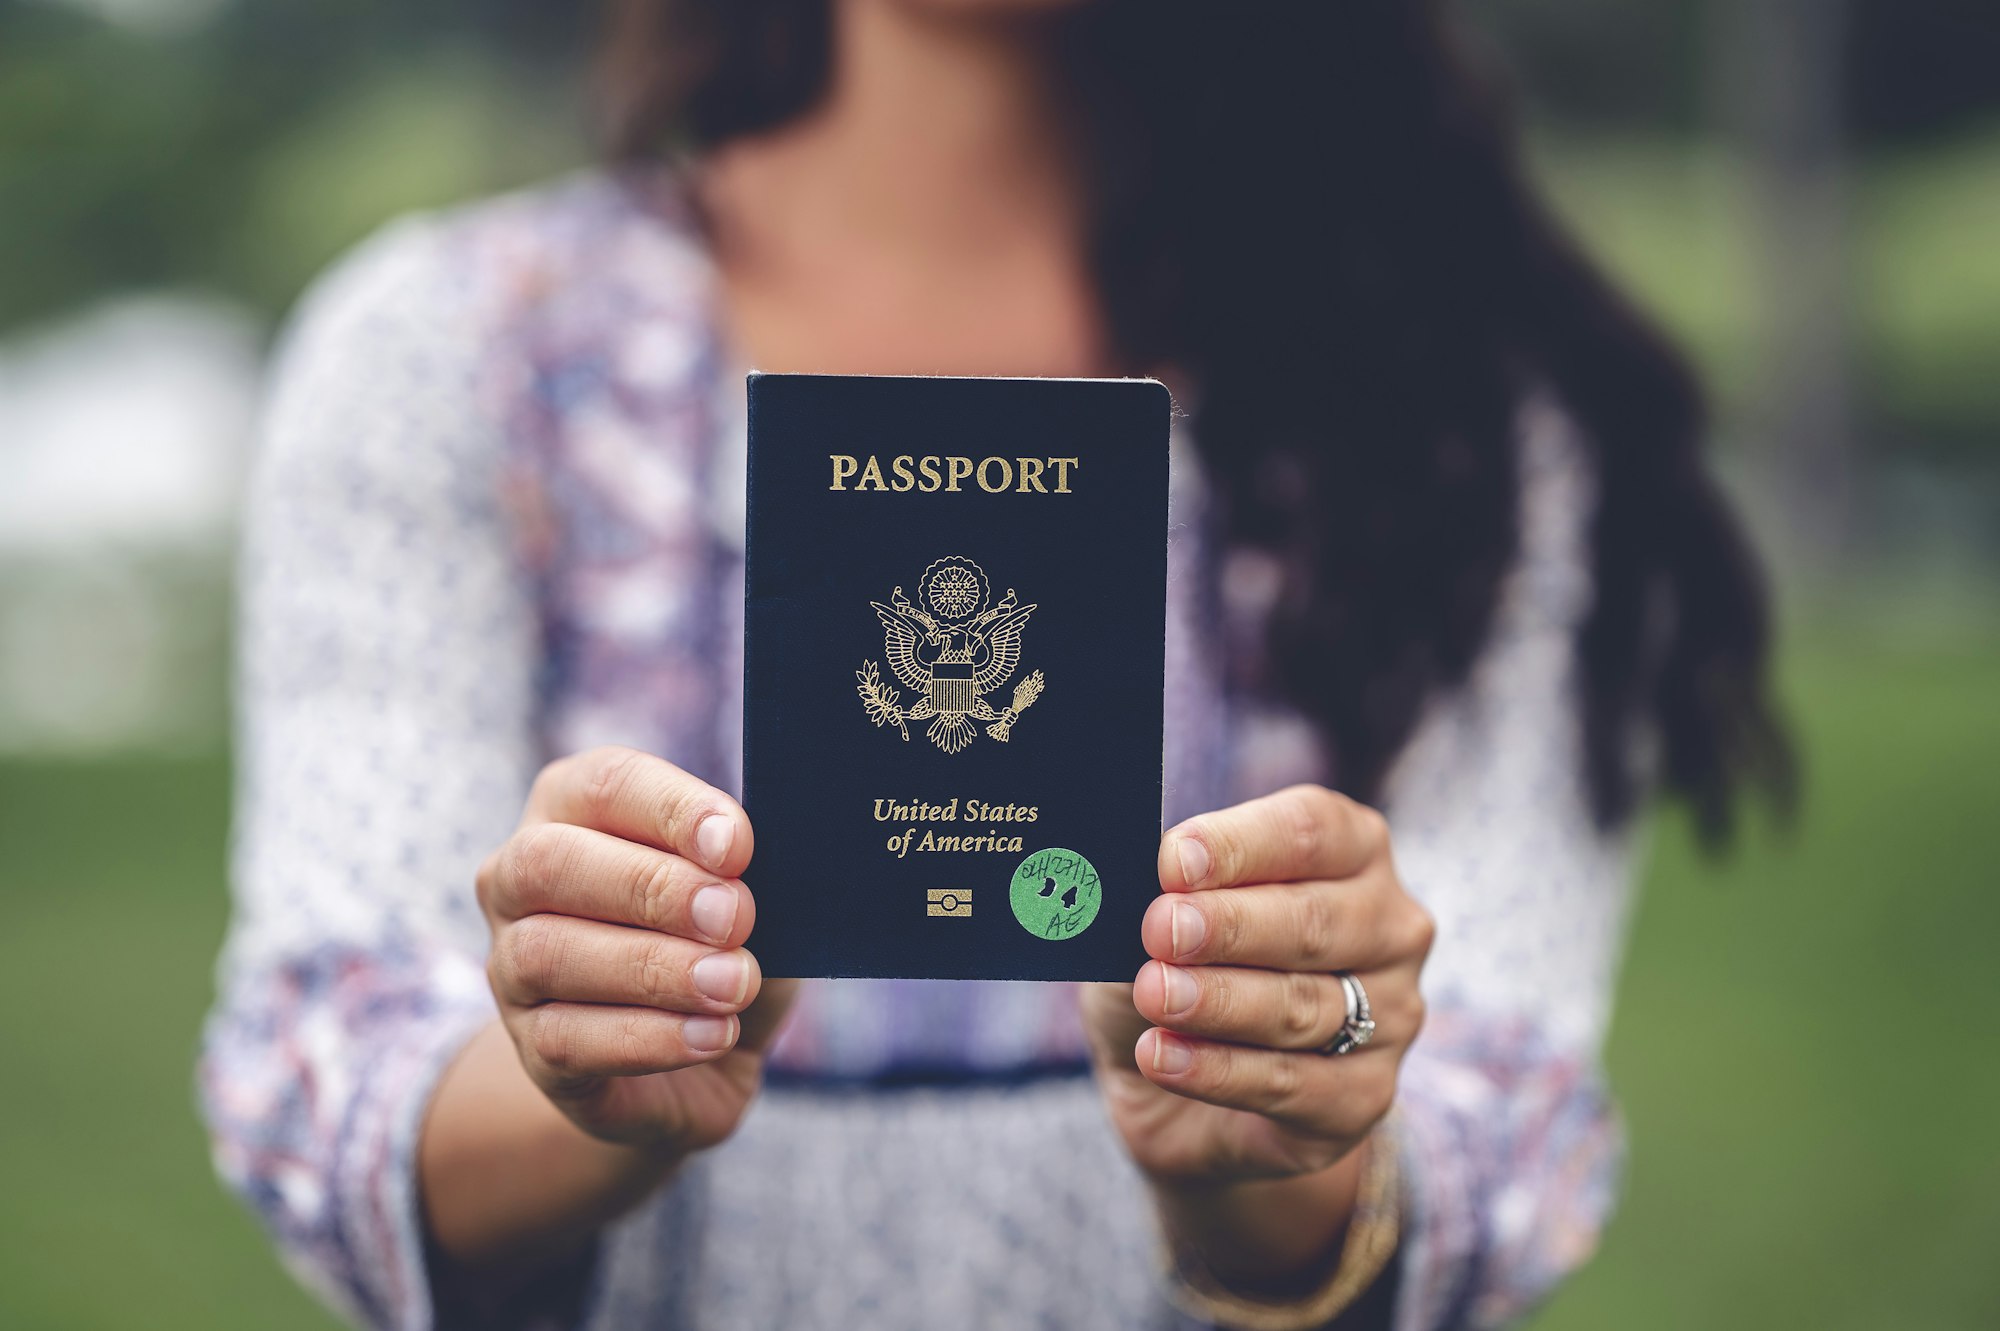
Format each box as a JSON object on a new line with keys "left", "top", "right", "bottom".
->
{"left": 200, "top": 212, "right": 538, "bottom": 1327}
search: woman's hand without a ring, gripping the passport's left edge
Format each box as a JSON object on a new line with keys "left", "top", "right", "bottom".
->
{"left": 478, "top": 747, "right": 798, "bottom": 1155}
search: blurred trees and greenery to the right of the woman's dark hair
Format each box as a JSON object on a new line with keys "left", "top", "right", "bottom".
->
{"left": 1464, "top": 0, "right": 2000, "bottom": 568}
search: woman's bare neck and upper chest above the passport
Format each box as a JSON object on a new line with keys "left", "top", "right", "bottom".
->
{"left": 700, "top": 0, "right": 1098, "bottom": 374}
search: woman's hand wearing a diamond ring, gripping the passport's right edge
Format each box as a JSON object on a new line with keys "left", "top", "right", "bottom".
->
{"left": 1084, "top": 785, "right": 1432, "bottom": 1185}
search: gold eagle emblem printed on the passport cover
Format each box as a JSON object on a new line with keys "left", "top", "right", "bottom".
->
{"left": 854, "top": 556, "right": 1042, "bottom": 753}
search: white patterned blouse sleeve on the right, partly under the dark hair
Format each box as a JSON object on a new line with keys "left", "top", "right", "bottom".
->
{"left": 1388, "top": 395, "right": 1630, "bottom": 1331}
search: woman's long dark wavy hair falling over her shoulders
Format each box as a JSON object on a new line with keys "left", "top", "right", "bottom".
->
{"left": 604, "top": 0, "right": 1790, "bottom": 841}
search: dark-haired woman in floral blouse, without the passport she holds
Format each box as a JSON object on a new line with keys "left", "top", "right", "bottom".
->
{"left": 204, "top": 0, "right": 1784, "bottom": 1327}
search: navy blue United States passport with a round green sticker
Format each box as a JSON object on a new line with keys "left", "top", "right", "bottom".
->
{"left": 744, "top": 374, "right": 1172, "bottom": 979}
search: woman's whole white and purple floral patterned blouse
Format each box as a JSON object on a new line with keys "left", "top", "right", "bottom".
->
{"left": 200, "top": 176, "right": 1630, "bottom": 1331}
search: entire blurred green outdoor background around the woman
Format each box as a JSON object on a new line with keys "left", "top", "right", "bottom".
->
{"left": 0, "top": 0, "right": 2000, "bottom": 1331}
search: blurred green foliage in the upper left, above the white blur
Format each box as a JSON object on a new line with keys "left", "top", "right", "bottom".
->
{"left": 0, "top": 0, "right": 588, "bottom": 330}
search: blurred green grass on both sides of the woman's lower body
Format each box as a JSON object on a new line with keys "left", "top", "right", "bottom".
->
{"left": 0, "top": 628, "right": 2000, "bottom": 1331}
